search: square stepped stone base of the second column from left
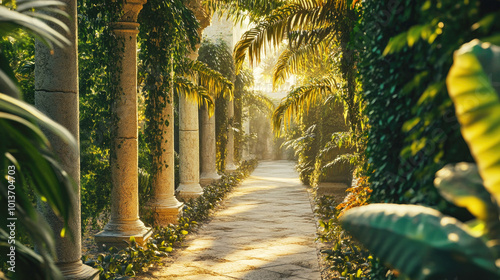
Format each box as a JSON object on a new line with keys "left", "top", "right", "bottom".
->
{"left": 95, "top": 220, "right": 153, "bottom": 249}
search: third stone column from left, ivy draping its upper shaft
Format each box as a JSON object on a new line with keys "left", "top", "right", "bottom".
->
{"left": 149, "top": 91, "right": 183, "bottom": 226}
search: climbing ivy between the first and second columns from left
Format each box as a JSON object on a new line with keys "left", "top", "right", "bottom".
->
{"left": 78, "top": 0, "right": 121, "bottom": 229}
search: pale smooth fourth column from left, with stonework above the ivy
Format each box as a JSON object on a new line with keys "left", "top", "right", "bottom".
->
{"left": 178, "top": 0, "right": 210, "bottom": 200}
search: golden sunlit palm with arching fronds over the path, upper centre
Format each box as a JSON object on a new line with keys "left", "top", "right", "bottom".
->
{"left": 234, "top": 0, "right": 361, "bottom": 136}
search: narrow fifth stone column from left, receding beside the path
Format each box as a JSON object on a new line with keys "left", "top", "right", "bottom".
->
{"left": 200, "top": 108, "right": 220, "bottom": 186}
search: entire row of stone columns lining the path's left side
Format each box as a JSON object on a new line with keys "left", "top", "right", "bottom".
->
{"left": 35, "top": 0, "right": 234, "bottom": 279}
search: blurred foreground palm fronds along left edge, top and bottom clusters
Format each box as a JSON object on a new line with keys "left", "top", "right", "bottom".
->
{"left": 0, "top": 1, "right": 78, "bottom": 279}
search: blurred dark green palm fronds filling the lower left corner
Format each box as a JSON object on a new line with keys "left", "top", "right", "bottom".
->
{"left": 0, "top": 93, "right": 78, "bottom": 279}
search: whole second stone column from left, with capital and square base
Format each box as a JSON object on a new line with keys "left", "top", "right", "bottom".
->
{"left": 95, "top": 0, "right": 152, "bottom": 247}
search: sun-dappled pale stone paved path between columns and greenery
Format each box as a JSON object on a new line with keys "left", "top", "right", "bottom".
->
{"left": 143, "top": 161, "right": 321, "bottom": 280}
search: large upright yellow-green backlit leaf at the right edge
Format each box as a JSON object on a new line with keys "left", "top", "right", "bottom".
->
{"left": 446, "top": 40, "right": 500, "bottom": 201}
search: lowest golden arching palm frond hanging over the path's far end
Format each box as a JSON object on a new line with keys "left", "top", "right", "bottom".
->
{"left": 272, "top": 76, "right": 338, "bottom": 135}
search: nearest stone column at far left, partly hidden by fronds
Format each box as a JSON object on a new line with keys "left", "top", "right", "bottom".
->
{"left": 35, "top": 0, "right": 99, "bottom": 279}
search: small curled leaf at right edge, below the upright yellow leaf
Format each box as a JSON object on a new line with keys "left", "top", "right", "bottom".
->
{"left": 434, "top": 162, "right": 498, "bottom": 223}
